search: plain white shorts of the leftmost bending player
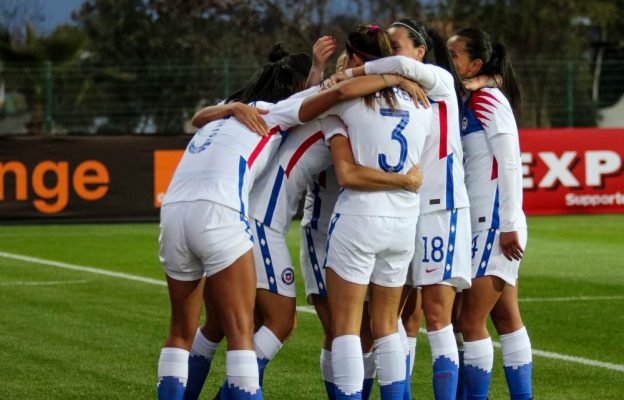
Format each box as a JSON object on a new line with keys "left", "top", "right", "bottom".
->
{"left": 159, "top": 200, "right": 253, "bottom": 281}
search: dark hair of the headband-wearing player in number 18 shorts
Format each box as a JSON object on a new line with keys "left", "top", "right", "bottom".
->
{"left": 390, "top": 18, "right": 466, "bottom": 108}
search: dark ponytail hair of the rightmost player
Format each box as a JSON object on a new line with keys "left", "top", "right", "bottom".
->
{"left": 455, "top": 28, "right": 522, "bottom": 113}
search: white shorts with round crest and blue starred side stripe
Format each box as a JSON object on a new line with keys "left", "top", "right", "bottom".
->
{"left": 250, "top": 218, "right": 296, "bottom": 297}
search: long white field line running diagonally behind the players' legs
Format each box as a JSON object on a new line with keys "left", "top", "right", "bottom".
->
{"left": 0, "top": 251, "right": 624, "bottom": 372}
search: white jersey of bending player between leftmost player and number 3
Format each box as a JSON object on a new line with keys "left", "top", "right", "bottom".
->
{"left": 249, "top": 116, "right": 347, "bottom": 235}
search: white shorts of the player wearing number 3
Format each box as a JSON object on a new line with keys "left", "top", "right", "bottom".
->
{"left": 326, "top": 213, "right": 418, "bottom": 287}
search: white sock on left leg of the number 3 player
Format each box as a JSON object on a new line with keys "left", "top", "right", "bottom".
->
{"left": 332, "top": 335, "right": 364, "bottom": 396}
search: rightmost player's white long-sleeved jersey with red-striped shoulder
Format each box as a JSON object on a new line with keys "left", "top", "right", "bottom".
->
{"left": 462, "top": 89, "right": 526, "bottom": 232}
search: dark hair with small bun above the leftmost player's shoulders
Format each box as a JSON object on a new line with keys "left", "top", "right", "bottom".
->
{"left": 225, "top": 43, "right": 312, "bottom": 103}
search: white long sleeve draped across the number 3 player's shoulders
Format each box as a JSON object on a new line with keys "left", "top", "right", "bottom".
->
{"left": 364, "top": 56, "right": 437, "bottom": 92}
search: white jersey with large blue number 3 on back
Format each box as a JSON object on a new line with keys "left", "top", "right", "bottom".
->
{"left": 328, "top": 88, "right": 431, "bottom": 218}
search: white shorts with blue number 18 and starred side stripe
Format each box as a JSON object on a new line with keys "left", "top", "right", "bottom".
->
{"left": 408, "top": 208, "right": 472, "bottom": 289}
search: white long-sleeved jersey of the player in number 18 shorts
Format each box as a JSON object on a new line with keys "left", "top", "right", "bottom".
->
{"left": 364, "top": 56, "right": 469, "bottom": 214}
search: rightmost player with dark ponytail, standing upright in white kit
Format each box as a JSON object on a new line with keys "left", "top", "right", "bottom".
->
{"left": 448, "top": 28, "right": 532, "bottom": 399}
